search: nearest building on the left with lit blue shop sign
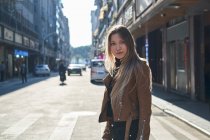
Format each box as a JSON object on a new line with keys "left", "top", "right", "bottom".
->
{"left": 0, "top": 0, "right": 39, "bottom": 79}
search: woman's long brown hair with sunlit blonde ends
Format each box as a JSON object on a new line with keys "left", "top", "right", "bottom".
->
{"left": 105, "top": 25, "right": 145, "bottom": 98}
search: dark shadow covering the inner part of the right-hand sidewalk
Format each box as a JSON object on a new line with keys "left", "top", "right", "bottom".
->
{"left": 152, "top": 86, "right": 210, "bottom": 121}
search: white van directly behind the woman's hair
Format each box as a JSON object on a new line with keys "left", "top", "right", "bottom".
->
{"left": 90, "top": 59, "right": 108, "bottom": 83}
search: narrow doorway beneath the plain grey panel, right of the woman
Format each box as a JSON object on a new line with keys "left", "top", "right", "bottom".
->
{"left": 167, "top": 40, "right": 189, "bottom": 94}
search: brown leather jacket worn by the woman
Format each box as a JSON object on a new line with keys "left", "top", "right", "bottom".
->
{"left": 99, "top": 61, "right": 152, "bottom": 140}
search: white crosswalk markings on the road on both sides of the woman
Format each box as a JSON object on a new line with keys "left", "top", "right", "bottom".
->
{"left": 0, "top": 112, "right": 208, "bottom": 140}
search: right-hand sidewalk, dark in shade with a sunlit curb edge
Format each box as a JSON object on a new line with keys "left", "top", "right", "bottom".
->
{"left": 152, "top": 85, "right": 210, "bottom": 137}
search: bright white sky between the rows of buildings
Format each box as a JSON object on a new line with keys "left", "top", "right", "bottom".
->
{"left": 62, "top": 0, "right": 95, "bottom": 47}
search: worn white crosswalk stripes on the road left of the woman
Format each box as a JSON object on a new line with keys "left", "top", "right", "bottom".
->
{"left": 0, "top": 111, "right": 96, "bottom": 140}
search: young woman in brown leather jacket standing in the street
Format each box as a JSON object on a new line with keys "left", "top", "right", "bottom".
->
{"left": 99, "top": 25, "right": 151, "bottom": 140}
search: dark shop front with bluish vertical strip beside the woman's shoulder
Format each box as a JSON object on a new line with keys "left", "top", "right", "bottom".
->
{"left": 136, "top": 29, "right": 163, "bottom": 85}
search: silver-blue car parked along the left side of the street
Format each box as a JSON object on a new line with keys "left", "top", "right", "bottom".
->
{"left": 34, "top": 64, "right": 50, "bottom": 76}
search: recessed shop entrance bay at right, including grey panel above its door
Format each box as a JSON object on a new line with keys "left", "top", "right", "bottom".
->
{"left": 166, "top": 20, "right": 190, "bottom": 96}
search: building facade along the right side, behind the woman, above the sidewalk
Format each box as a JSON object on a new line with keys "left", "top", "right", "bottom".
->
{"left": 91, "top": 0, "right": 210, "bottom": 101}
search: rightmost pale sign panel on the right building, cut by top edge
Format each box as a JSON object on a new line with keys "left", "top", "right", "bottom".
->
{"left": 136, "top": 0, "right": 154, "bottom": 16}
